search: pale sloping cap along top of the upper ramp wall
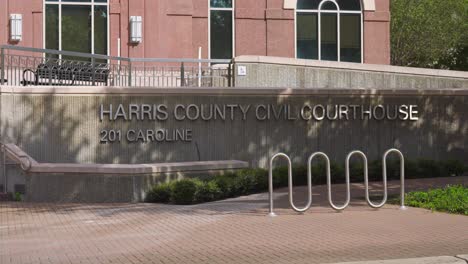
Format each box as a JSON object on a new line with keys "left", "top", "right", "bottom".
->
{"left": 234, "top": 56, "right": 468, "bottom": 80}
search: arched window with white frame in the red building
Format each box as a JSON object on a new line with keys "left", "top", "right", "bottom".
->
{"left": 296, "top": 0, "right": 362, "bottom": 62}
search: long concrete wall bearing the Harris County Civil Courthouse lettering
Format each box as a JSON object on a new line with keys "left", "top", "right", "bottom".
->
{"left": 0, "top": 87, "right": 468, "bottom": 167}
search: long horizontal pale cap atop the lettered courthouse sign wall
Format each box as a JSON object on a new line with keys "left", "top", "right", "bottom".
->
{"left": 0, "top": 86, "right": 468, "bottom": 96}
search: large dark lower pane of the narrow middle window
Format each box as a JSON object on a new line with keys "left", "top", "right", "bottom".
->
{"left": 210, "top": 11, "right": 232, "bottom": 59}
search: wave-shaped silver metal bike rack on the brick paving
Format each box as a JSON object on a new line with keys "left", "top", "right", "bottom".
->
{"left": 268, "top": 148, "right": 407, "bottom": 216}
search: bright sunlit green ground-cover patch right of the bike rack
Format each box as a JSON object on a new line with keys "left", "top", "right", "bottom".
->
{"left": 389, "top": 185, "right": 468, "bottom": 215}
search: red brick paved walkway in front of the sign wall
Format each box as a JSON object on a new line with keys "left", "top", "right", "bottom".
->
{"left": 0, "top": 177, "right": 468, "bottom": 264}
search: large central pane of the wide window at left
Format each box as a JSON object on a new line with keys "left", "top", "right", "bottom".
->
{"left": 62, "top": 5, "right": 91, "bottom": 59}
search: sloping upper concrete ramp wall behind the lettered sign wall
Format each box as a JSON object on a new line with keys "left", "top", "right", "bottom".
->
{"left": 235, "top": 56, "right": 468, "bottom": 90}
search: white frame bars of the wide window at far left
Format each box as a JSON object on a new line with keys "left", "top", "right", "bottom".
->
{"left": 42, "top": 0, "right": 110, "bottom": 59}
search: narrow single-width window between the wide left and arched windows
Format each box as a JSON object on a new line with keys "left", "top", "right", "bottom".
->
{"left": 209, "top": 0, "right": 234, "bottom": 59}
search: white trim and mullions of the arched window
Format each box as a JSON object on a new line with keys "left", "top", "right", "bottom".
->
{"left": 294, "top": 0, "right": 364, "bottom": 64}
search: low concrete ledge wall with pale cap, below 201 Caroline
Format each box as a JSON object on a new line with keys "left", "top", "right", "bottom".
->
{"left": 3, "top": 144, "right": 249, "bottom": 203}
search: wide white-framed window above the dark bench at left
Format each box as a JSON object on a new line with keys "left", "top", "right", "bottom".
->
{"left": 44, "top": 0, "right": 109, "bottom": 58}
